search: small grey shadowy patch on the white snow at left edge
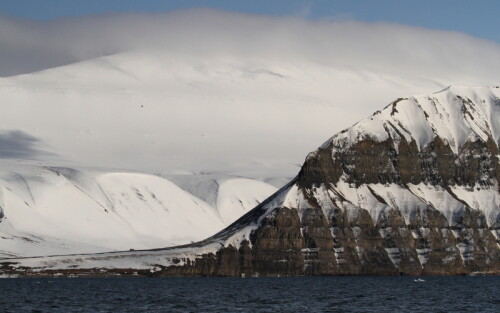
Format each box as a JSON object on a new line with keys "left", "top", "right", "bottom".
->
{"left": 0, "top": 130, "right": 51, "bottom": 160}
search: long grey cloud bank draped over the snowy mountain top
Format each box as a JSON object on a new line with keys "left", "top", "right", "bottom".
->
{"left": 0, "top": 9, "right": 500, "bottom": 78}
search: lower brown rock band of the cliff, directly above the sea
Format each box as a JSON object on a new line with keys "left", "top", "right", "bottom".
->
{"left": 148, "top": 197, "right": 500, "bottom": 277}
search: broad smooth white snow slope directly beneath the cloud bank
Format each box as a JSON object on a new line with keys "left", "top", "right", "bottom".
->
{"left": 0, "top": 52, "right": 450, "bottom": 178}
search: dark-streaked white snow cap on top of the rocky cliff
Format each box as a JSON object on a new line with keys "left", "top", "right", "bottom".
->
{"left": 323, "top": 86, "right": 500, "bottom": 152}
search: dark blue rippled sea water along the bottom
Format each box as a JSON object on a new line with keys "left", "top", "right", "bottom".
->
{"left": 0, "top": 277, "right": 500, "bottom": 313}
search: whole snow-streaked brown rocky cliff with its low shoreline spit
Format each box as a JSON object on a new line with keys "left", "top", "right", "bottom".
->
{"left": 0, "top": 87, "right": 500, "bottom": 276}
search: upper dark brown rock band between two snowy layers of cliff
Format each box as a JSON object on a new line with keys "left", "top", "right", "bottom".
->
{"left": 298, "top": 137, "right": 499, "bottom": 188}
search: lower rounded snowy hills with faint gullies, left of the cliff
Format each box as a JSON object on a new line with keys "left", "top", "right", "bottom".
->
{"left": 0, "top": 162, "right": 276, "bottom": 257}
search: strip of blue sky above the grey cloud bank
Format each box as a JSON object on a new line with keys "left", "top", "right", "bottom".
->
{"left": 0, "top": 0, "right": 500, "bottom": 42}
